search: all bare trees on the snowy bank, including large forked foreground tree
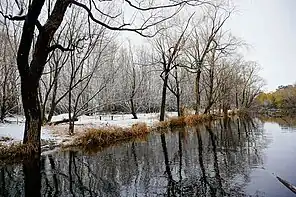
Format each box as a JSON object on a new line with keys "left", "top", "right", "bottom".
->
{"left": 0, "top": 0, "right": 262, "bottom": 154}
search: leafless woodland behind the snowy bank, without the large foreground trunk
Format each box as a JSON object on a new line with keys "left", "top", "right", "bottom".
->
{"left": 0, "top": 1, "right": 264, "bottom": 122}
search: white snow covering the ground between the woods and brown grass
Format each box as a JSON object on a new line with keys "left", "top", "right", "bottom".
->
{"left": 0, "top": 112, "right": 177, "bottom": 148}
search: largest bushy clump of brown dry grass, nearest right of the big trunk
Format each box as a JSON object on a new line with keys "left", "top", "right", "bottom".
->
{"left": 72, "top": 123, "right": 150, "bottom": 148}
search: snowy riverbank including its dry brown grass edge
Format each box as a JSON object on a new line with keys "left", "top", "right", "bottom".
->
{"left": 0, "top": 112, "right": 215, "bottom": 160}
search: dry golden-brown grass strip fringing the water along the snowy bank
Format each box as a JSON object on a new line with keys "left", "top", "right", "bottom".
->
{"left": 0, "top": 115, "right": 215, "bottom": 161}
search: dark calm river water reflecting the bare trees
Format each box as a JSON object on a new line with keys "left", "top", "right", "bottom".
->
{"left": 0, "top": 119, "right": 296, "bottom": 197}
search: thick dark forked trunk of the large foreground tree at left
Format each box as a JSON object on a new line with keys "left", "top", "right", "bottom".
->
{"left": 17, "top": 0, "right": 70, "bottom": 154}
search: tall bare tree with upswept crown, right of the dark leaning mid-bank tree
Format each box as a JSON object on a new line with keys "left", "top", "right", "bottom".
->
{"left": 185, "top": 1, "right": 233, "bottom": 114}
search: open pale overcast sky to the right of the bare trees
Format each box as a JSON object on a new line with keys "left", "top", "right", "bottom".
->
{"left": 228, "top": 0, "right": 296, "bottom": 91}
